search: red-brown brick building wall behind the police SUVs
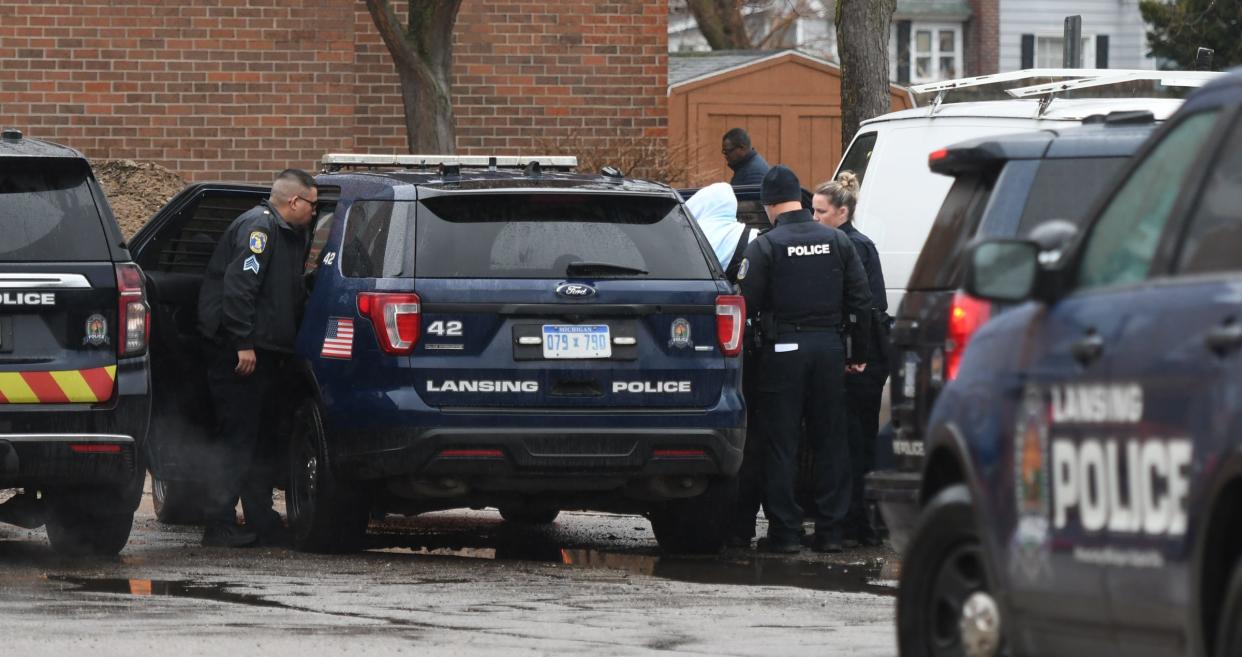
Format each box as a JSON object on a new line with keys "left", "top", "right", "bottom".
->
{"left": 0, "top": 0, "right": 668, "bottom": 181}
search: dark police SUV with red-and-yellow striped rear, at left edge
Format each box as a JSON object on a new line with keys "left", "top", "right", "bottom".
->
{"left": 0, "top": 129, "right": 150, "bottom": 554}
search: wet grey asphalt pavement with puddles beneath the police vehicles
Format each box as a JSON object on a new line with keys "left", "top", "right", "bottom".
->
{"left": 0, "top": 484, "right": 895, "bottom": 657}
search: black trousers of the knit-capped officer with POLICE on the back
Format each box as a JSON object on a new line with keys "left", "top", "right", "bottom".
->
{"left": 758, "top": 332, "right": 851, "bottom": 541}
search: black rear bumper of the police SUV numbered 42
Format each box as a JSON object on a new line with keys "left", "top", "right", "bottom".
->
{"left": 332, "top": 427, "right": 745, "bottom": 483}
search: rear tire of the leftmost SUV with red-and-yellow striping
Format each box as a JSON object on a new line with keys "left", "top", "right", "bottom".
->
{"left": 47, "top": 491, "right": 134, "bottom": 556}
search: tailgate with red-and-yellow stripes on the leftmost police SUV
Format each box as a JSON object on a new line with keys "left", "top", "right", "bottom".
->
{"left": 0, "top": 159, "right": 118, "bottom": 405}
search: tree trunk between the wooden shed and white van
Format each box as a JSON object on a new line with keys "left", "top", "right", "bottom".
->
{"left": 836, "top": 0, "right": 897, "bottom": 147}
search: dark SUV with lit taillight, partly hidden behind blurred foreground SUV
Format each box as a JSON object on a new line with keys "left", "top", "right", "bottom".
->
{"left": 867, "top": 112, "right": 1156, "bottom": 550}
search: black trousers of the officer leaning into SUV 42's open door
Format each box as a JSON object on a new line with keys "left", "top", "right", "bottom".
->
{"left": 205, "top": 343, "right": 284, "bottom": 532}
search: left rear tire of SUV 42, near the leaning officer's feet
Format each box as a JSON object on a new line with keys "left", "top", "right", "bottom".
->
{"left": 286, "top": 400, "right": 370, "bottom": 554}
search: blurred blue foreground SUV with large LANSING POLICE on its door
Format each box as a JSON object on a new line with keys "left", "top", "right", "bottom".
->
{"left": 898, "top": 71, "right": 1242, "bottom": 657}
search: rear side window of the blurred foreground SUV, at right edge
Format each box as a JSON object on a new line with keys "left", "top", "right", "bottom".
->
{"left": 1177, "top": 123, "right": 1242, "bottom": 273}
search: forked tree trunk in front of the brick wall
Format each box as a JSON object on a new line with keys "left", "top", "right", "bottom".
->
{"left": 366, "top": 0, "right": 461, "bottom": 155}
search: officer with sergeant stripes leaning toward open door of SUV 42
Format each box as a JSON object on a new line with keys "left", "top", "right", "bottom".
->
{"left": 199, "top": 169, "right": 319, "bottom": 548}
